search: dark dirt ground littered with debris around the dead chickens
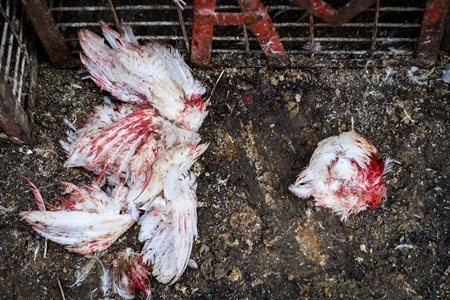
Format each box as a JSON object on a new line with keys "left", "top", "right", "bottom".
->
{"left": 0, "top": 50, "right": 450, "bottom": 299}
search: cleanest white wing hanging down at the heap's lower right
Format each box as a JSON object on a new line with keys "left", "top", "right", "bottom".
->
{"left": 129, "top": 140, "right": 208, "bottom": 283}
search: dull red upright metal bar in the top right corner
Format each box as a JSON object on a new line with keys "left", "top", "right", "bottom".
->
{"left": 416, "top": 0, "right": 450, "bottom": 67}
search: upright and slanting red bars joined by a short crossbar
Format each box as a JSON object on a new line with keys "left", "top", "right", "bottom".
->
{"left": 191, "top": 0, "right": 289, "bottom": 66}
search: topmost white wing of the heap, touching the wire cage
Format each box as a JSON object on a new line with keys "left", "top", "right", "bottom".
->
{"left": 79, "top": 22, "right": 207, "bottom": 131}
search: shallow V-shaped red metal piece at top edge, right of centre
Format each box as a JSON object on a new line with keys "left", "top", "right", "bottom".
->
{"left": 291, "top": 0, "right": 377, "bottom": 25}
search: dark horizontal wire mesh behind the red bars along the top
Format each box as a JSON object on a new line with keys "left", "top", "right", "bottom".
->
{"left": 39, "top": 0, "right": 448, "bottom": 67}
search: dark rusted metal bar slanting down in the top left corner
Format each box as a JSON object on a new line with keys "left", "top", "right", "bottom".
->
{"left": 22, "top": 0, "right": 80, "bottom": 68}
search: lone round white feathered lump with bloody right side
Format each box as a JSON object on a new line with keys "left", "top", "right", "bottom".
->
{"left": 289, "top": 131, "right": 391, "bottom": 220}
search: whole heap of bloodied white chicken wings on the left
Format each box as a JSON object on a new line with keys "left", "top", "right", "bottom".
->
{"left": 21, "top": 19, "right": 208, "bottom": 299}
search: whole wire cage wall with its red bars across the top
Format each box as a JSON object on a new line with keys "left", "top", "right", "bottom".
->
{"left": 29, "top": 0, "right": 449, "bottom": 67}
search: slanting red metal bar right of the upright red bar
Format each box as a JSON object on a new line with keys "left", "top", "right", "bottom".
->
{"left": 238, "top": 0, "right": 289, "bottom": 66}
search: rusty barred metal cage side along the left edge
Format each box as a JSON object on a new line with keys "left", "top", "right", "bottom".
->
{"left": 0, "top": 1, "right": 37, "bottom": 143}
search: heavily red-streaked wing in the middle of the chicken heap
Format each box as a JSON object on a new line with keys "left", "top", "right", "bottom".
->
{"left": 61, "top": 105, "right": 146, "bottom": 175}
